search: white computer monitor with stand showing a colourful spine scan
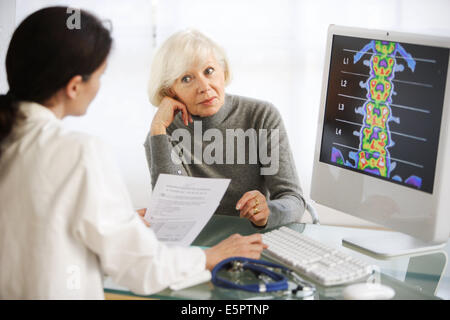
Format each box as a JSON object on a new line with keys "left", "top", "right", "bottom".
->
{"left": 311, "top": 25, "right": 450, "bottom": 257}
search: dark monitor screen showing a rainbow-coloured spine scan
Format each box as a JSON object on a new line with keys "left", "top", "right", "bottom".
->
{"left": 319, "top": 35, "right": 449, "bottom": 194}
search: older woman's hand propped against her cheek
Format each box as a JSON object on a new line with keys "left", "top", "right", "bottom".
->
{"left": 150, "top": 97, "right": 194, "bottom": 136}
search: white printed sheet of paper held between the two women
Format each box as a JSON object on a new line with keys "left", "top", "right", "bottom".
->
{"left": 144, "top": 174, "right": 230, "bottom": 246}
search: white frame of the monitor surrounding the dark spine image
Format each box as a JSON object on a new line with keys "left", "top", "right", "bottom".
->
{"left": 311, "top": 25, "right": 450, "bottom": 241}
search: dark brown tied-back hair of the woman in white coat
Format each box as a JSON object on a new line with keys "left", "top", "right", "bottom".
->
{"left": 0, "top": 7, "right": 112, "bottom": 155}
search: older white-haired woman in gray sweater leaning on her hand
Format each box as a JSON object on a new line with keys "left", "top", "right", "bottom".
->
{"left": 144, "top": 30, "right": 305, "bottom": 228}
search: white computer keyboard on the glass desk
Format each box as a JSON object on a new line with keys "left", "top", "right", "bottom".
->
{"left": 262, "top": 227, "right": 374, "bottom": 286}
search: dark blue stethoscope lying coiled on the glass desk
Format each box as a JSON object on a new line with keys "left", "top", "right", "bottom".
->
{"left": 211, "top": 257, "right": 315, "bottom": 297}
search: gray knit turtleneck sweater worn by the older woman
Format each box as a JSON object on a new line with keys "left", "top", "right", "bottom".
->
{"left": 144, "top": 94, "right": 305, "bottom": 228}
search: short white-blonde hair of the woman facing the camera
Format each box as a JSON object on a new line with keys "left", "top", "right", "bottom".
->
{"left": 148, "top": 29, "right": 231, "bottom": 106}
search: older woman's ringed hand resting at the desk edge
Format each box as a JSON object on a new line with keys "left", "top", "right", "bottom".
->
{"left": 236, "top": 190, "right": 270, "bottom": 227}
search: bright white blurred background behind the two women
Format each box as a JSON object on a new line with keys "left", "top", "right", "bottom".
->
{"left": 0, "top": 0, "right": 450, "bottom": 227}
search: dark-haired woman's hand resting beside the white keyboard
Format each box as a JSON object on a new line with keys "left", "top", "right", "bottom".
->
{"left": 205, "top": 233, "right": 268, "bottom": 270}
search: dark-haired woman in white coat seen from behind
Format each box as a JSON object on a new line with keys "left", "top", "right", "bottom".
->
{"left": 0, "top": 7, "right": 265, "bottom": 299}
